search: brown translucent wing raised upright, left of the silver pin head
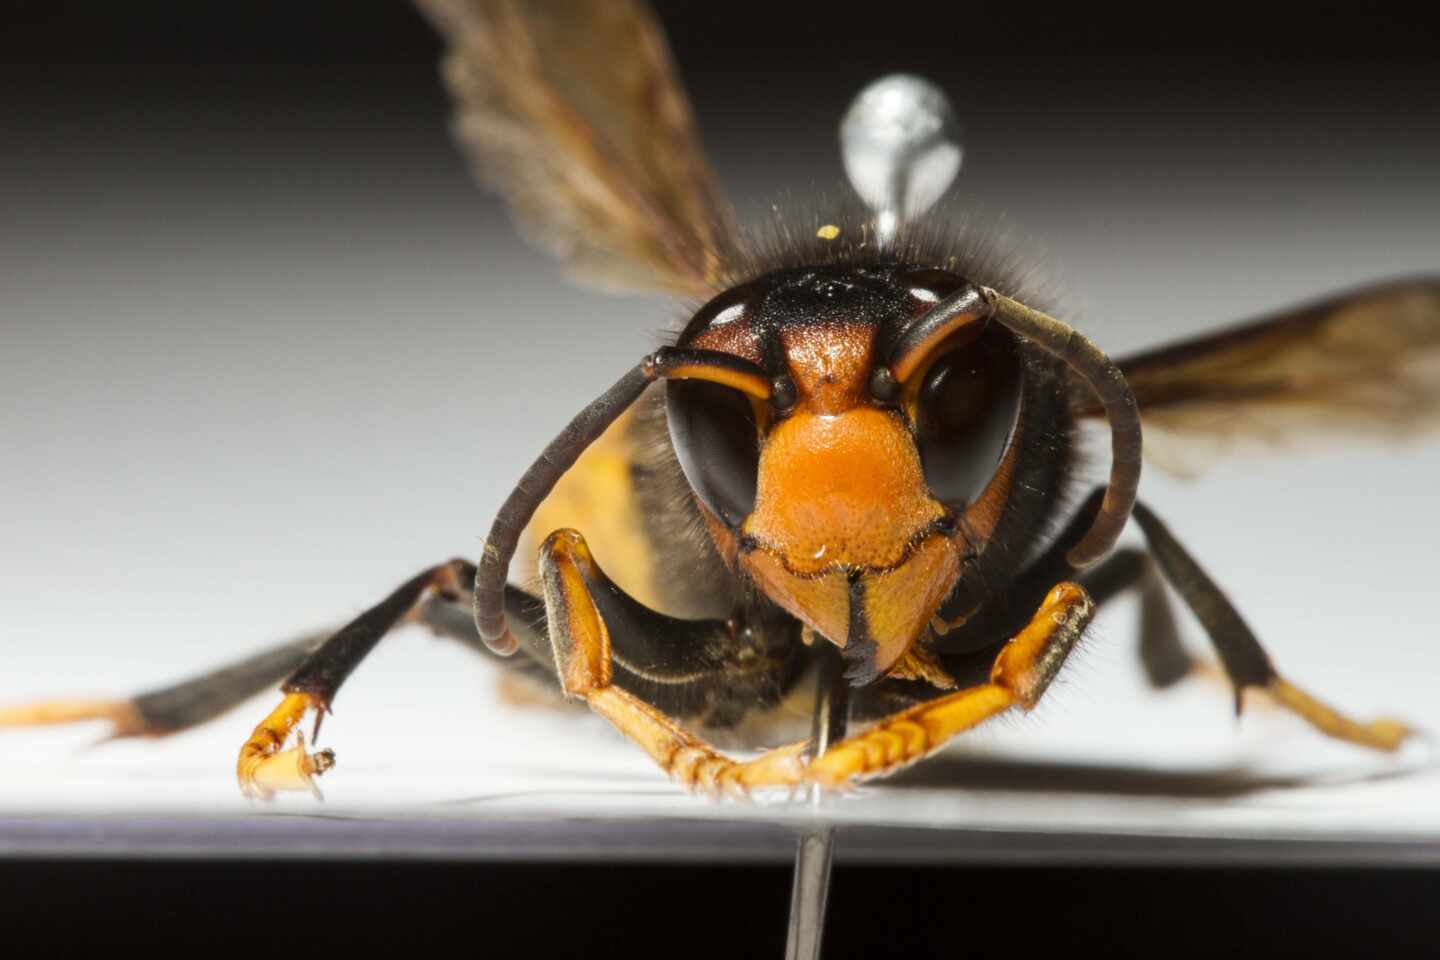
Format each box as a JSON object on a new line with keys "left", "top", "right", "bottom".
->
{"left": 418, "top": 0, "right": 734, "bottom": 295}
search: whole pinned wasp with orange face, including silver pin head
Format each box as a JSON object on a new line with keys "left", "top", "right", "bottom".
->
{"left": 0, "top": 0, "right": 1440, "bottom": 797}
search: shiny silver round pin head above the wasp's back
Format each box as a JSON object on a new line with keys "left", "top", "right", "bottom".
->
{"left": 840, "top": 73, "right": 963, "bottom": 245}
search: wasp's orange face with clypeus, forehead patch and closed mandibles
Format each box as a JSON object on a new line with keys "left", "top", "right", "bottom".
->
{"left": 739, "top": 325, "right": 959, "bottom": 676}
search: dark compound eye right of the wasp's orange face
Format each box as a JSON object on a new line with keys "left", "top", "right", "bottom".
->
{"left": 916, "top": 330, "right": 1021, "bottom": 508}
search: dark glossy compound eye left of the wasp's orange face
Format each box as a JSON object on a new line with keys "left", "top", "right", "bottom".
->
{"left": 665, "top": 380, "right": 760, "bottom": 528}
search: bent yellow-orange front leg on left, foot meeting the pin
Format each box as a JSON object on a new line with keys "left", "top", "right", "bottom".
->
{"left": 540, "top": 530, "right": 809, "bottom": 794}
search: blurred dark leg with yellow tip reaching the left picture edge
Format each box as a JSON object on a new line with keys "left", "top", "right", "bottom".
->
{"left": 0, "top": 632, "right": 330, "bottom": 737}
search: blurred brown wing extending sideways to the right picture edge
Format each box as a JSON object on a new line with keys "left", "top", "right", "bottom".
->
{"left": 1071, "top": 278, "right": 1440, "bottom": 474}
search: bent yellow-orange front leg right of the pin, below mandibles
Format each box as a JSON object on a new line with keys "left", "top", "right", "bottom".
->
{"left": 805, "top": 583, "right": 1094, "bottom": 789}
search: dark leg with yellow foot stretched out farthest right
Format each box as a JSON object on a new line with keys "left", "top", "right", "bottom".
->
{"left": 1135, "top": 504, "right": 1416, "bottom": 751}
